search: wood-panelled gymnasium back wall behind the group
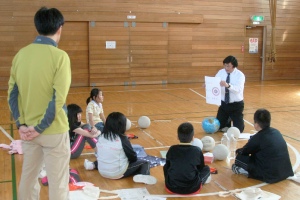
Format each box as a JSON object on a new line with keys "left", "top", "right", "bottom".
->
{"left": 0, "top": 0, "right": 300, "bottom": 89}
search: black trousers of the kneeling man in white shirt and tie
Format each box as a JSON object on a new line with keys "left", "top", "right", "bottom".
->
{"left": 217, "top": 101, "right": 245, "bottom": 133}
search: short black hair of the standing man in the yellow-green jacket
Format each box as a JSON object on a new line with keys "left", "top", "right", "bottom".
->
{"left": 34, "top": 7, "right": 65, "bottom": 36}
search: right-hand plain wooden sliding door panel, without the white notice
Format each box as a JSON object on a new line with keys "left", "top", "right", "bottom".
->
{"left": 129, "top": 23, "right": 168, "bottom": 84}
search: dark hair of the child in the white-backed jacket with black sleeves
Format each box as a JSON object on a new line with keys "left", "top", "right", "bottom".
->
{"left": 102, "top": 112, "right": 127, "bottom": 141}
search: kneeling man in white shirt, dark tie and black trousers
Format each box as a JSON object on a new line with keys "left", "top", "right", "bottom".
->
{"left": 216, "top": 56, "right": 245, "bottom": 133}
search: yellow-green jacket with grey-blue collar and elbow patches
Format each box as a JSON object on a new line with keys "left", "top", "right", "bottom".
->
{"left": 8, "top": 36, "right": 71, "bottom": 134}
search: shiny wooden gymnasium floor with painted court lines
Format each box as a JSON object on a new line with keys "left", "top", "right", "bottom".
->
{"left": 0, "top": 80, "right": 300, "bottom": 200}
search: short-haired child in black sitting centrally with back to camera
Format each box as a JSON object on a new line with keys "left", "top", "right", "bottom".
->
{"left": 163, "top": 123, "right": 211, "bottom": 194}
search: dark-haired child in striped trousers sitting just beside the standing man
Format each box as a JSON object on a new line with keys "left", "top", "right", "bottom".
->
{"left": 67, "top": 104, "right": 101, "bottom": 159}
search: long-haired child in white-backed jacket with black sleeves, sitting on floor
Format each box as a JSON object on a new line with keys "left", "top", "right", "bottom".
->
{"left": 84, "top": 112, "right": 156, "bottom": 184}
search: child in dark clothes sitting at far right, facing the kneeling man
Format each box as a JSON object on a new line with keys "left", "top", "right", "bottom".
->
{"left": 232, "top": 108, "right": 294, "bottom": 183}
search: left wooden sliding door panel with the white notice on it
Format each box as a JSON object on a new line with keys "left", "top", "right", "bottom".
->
{"left": 89, "top": 22, "right": 130, "bottom": 86}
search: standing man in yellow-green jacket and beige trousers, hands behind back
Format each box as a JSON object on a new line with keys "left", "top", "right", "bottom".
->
{"left": 8, "top": 7, "right": 71, "bottom": 200}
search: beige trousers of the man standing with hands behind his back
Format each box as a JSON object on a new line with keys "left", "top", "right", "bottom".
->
{"left": 18, "top": 132, "right": 70, "bottom": 200}
